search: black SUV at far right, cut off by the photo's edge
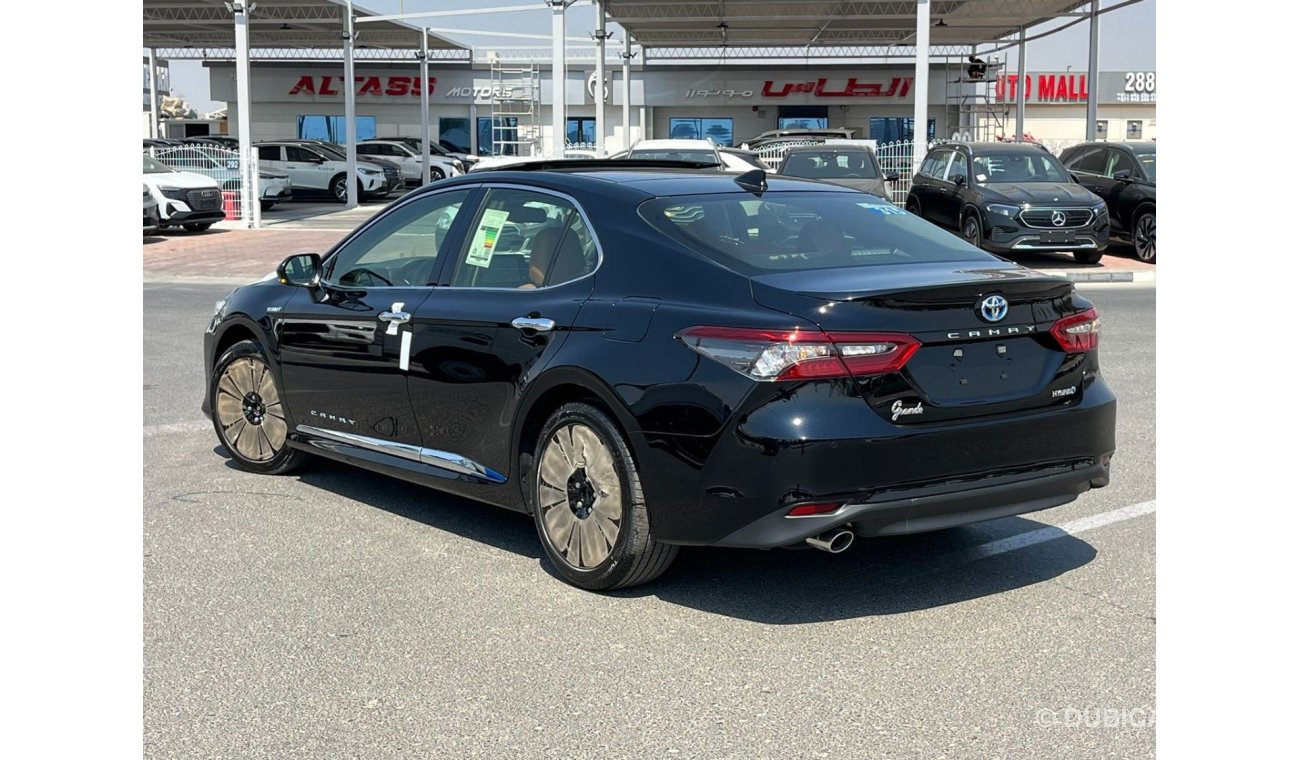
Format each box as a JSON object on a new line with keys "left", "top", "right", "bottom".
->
{"left": 1061, "top": 143, "right": 1156, "bottom": 264}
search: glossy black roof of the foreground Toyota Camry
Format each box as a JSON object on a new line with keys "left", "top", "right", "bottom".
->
{"left": 416, "top": 161, "right": 858, "bottom": 203}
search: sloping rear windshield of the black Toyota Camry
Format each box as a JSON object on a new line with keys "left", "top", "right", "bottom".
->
{"left": 640, "top": 192, "right": 995, "bottom": 277}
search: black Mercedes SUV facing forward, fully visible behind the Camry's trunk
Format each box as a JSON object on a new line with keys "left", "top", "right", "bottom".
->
{"left": 906, "top": 143, "right": 1110, "bottom": 264}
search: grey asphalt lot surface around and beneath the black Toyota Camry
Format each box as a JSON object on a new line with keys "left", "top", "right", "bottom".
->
{"left": 143, "top": 282, "right": 1156, "bottom": 760}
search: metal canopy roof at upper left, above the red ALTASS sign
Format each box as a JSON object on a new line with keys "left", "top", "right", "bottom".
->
{"left": 143, "top": 0, "right": 469, "bottom": 60}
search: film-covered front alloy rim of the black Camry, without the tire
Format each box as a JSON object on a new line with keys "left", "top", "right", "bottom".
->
{"left": 216, "top": 356, "right": 289, "bottom": 462}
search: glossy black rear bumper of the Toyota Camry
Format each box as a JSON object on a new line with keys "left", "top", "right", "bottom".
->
{"left": 637, "top": 375, "right": 1115, "bottom": 548}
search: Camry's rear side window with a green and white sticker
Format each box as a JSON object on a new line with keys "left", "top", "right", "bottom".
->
{"left": 451, "top": 187, "right": 598, "bottom": 290}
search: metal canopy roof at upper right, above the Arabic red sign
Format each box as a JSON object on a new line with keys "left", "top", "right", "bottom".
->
{"left": 605, "top": 0, "right": 1088, "bottom": 60}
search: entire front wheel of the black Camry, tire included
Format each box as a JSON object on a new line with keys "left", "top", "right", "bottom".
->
{"left": 208, "top": 340, "right": 307, "bottom": 475}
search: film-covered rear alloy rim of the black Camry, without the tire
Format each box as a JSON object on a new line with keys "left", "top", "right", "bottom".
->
{"left": 537, "top": 422, "right": 623, "bottom": 570}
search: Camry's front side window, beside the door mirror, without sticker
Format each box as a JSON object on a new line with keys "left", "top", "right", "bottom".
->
{"left": 325, "top": 190, "right": 469, "bottom": 287}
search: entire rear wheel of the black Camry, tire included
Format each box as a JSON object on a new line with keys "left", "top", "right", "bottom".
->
{"left": 528, "top": 401, "right": 677, "bottom": 591}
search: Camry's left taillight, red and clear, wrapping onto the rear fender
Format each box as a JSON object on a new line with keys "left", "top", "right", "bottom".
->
{"left": 677, "top": 327, "right": 920, "bottom": 381}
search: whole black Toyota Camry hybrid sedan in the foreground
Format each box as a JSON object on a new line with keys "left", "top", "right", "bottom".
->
{"left": 203, "top": 161, "right": 1115, "bottom": 590}
